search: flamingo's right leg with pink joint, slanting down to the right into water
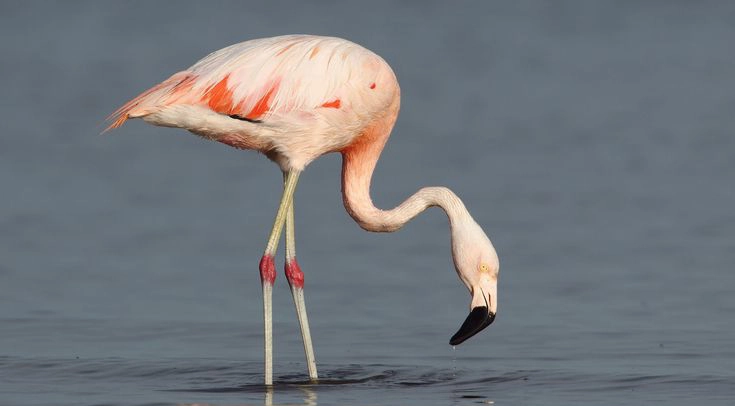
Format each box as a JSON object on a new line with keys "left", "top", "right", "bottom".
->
{"left": 285, "top": 190, "right": 318, "bottom": 382}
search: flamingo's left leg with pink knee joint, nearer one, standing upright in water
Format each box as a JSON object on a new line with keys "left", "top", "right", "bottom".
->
{"left": 260, "top": 171, "right": 300, "bottom": 385}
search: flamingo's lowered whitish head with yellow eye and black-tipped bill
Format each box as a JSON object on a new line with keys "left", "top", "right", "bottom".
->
{"left": 449, "top": 219, "right": 500, "bottom": 345}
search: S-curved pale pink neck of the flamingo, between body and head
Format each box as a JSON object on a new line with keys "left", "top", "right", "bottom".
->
{"left": 342, "top": 123, "right": 472, "bottom": 232}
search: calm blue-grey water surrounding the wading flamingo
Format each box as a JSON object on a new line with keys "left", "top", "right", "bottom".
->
{"left": 0, "top": 1, "right": 735, "bottom": 405}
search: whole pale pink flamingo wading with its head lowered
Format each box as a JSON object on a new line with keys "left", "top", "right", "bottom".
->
{"left": 105, "top": 35, "right": 499, "bottom": 385}
